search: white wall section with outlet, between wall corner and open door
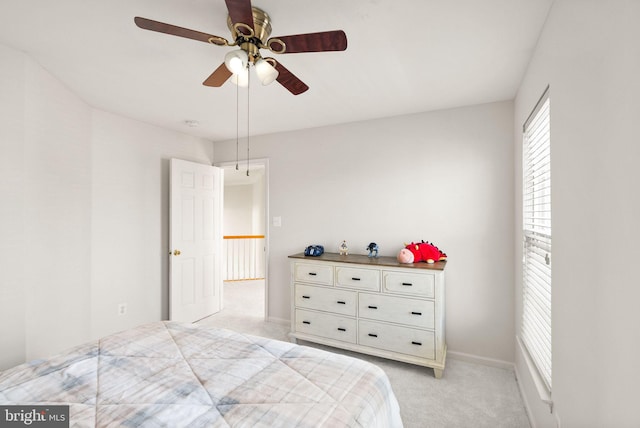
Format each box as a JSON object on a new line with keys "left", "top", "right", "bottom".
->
{"left": 91, "top": 109, "right": 212, "bottom": 338}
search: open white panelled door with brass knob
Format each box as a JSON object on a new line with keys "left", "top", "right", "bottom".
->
{"left": 169, "top": 159, "right": 223, "bottom": 322}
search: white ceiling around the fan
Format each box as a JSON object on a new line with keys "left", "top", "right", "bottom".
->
{"left": 0, "top": 0, "right": 553, "bottom": 141}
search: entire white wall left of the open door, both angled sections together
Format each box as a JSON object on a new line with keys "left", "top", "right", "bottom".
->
{"left": 0, "top": 46, "right": 212, "bottom": 369}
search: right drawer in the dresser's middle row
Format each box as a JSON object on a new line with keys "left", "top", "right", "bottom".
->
{"left": 358, "top": 293, "right": 435, "bottom": 328}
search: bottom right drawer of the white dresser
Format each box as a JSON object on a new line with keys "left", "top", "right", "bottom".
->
{"left": 358, "top": 320, "right": 435, "bottom": 360}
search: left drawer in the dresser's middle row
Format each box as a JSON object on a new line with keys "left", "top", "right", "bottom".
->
{"left": 295, "top": 284, "right": 358, "bottom": 317}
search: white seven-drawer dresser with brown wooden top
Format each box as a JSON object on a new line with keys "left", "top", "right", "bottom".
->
{"left": 289, "top": 253, "right": 447, "bottom": 378}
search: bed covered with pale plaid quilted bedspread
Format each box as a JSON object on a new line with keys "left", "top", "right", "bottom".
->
{"left": 0, "top": 321, "right": 402, "bottom": 428}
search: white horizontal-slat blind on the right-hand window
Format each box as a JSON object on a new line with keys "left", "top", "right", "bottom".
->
{"left": 521, "top": 88, "right": 551, "bottom": 391}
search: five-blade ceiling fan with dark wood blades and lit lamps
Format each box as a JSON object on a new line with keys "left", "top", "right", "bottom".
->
{"left": 134, "top": 0, "right": 347, "bottom": 95}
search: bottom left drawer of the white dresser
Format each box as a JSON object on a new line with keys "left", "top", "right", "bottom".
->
{"left": 296, "top": 309, "right": 357, "bottom": 343}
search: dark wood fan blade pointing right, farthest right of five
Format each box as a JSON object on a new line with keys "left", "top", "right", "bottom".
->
{"left": 267, "top": 30, "right": 347, "bottom": 53}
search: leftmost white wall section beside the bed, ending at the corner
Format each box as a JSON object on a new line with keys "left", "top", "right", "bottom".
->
{"left": 0, "top": 50, "right": 91, "bottom": 367}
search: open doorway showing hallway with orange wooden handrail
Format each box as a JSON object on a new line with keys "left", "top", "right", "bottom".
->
{"left": 216, "top": 159, "right": 269, "bottom": 320}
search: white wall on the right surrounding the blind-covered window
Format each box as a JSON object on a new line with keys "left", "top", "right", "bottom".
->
{"left": 514, "top": 0, "right": 640, "bottom": 428}
